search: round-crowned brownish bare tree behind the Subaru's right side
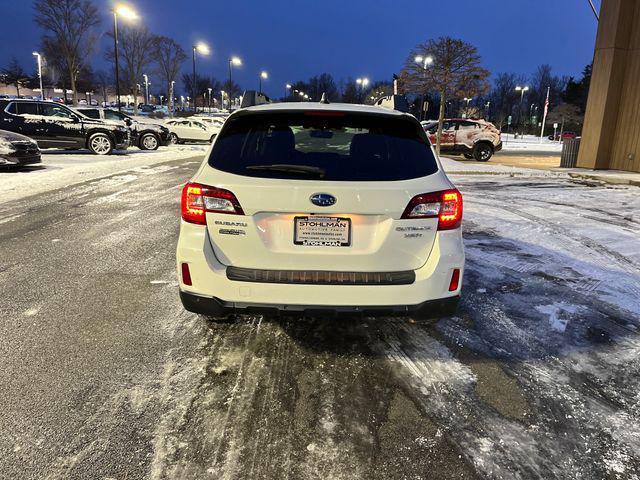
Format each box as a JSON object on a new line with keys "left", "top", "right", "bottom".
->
{"left": 402, "top": 37, "right": 489, "bottom": 153}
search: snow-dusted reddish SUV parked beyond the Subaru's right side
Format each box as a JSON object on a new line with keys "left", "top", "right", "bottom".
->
{"left": 424, "top": 118, "right": 502, "bottom": 162}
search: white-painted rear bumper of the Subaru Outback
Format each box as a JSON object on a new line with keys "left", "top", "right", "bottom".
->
{"left": 176, "top": 221, "right": 465, "bottom": 312}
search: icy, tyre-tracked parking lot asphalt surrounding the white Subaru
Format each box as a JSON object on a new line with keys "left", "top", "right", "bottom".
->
{"left": 0, "top": 158, "right": 640, "bottom": 480}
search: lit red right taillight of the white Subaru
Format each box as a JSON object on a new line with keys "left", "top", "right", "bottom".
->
{"left": 401, "top": 189, "right": 462, "bottom": 230}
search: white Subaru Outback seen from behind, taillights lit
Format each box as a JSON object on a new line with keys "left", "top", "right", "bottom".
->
{"left": 177, "top": 103, "right": 464, "bottom": 318}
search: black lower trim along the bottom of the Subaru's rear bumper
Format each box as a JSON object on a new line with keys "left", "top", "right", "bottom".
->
{"left": 180, "top": 291, "right": 460, "bottom": 318}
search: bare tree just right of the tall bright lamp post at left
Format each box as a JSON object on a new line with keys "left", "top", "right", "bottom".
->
{"left": 106, "top": 25, "right": 155, "bottom": 113}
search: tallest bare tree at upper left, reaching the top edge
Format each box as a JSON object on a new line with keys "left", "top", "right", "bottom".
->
{"left": 33, "top": 0, "right": 100, "bottom": 105}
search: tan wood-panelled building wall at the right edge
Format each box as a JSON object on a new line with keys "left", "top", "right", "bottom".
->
{"left": 578, "top": 0, "right": 640, "bottom": 172}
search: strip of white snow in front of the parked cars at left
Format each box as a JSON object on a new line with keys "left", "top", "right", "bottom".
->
{"left": 0, "top": 145, "right": 209, "bottom": 204}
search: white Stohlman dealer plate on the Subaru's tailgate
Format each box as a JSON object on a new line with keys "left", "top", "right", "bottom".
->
{"left": 293, "top": 216, "right": 351, "bottom": 247}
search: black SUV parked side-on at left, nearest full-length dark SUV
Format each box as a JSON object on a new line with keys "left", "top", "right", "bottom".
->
{"left": 0, "top": 100, "right": 129, "bottom": 155}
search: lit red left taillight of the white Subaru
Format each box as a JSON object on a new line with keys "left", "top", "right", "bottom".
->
{"left": 181, "top": 183, "right": 244, "bottom": 225}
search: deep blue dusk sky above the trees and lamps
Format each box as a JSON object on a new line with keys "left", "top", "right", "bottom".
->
{"left": 0, "top": 0, "right": 599, "bottom": 96}
